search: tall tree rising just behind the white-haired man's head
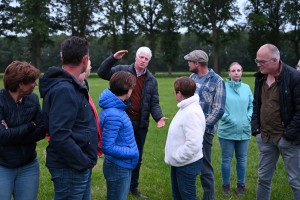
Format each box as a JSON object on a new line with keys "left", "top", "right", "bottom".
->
{"left": 132, "top": 0, "right": 163, "bottom": 74}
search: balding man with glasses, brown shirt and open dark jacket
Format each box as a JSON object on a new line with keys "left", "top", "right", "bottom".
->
{"left": 251, "top": 44, "right": 300, "bottom": 200}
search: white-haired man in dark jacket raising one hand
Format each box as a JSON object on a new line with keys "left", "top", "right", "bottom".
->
{"left": 97, "top": 47, "right": 167, "bottom": 199}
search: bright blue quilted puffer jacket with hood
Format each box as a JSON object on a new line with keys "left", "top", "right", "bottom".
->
{"left": 99, "top": 89, "right": 139, "bottom": 169}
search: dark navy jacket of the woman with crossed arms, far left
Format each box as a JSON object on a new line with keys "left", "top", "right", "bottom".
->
{"left": 0, "top": 89, "right": 45, "bottom": 168}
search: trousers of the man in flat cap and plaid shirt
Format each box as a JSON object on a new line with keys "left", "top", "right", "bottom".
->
{"left": 200, "top": 133, "right": 215, "bottom": 200}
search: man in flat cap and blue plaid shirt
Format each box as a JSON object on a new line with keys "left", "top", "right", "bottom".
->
{"left": 184, "top": 50, "right": 226, "bottom": 200}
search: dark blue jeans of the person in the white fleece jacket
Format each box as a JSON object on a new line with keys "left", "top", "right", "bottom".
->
{"left": 171, "top": 159, "right": 203, "bottom": 200}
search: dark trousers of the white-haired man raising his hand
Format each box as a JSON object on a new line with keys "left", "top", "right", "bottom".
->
{"left": 130, "top": 121, "right": 148, "bottom": 191}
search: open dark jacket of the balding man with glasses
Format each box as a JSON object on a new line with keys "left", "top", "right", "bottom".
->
{"left": 251, "top": 63, "right": 300, "bottom": 144}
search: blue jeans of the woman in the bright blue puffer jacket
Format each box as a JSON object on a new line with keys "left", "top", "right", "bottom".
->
{"left": 103, "top": 158, "right": 132, "bottom": 200}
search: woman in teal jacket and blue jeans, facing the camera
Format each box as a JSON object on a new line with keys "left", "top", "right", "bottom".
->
{"left": 218, "top": 62, "right": 253, "bottom": 196}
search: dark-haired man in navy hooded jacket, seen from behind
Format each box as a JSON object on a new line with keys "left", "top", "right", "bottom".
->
{"left": 39, "top": 37, "right": 98, "bottom": 199}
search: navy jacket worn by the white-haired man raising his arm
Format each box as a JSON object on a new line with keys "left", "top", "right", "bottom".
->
{"left": 97, "top": 55, "right": 163, "bottom": 128}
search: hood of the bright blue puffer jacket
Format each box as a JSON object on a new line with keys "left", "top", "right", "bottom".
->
{"left": 98, "top": 88, "right": 129, "bottom": 110}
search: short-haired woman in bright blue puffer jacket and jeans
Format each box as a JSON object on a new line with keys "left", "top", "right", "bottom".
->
{"left": 99, "top": 71, "right": 139, "bottom": 200}
